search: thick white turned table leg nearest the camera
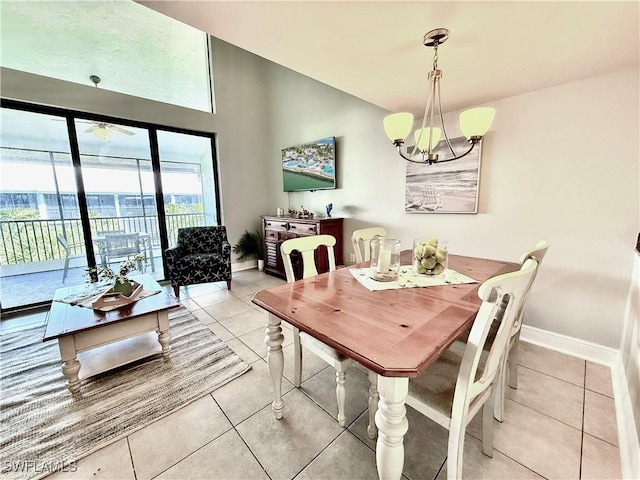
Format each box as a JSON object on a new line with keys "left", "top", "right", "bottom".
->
{"left": 376, "top": 376, "right": 409, "bottom": 480}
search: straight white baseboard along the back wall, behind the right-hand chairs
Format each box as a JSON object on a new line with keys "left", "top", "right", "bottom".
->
{"left": 520, "top": 325, "right": 619, "bottom": 367}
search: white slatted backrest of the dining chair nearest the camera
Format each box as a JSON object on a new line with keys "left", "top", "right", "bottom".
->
{"left": 452, "top": 259, "right": 538, "bottom": 416}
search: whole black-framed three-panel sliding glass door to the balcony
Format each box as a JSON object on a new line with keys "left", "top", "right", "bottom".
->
{"left": 0, "top": 101, "right": 219, "bottom": 311}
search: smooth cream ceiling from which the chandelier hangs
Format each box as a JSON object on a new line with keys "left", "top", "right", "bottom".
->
{"left": 138, "top": 0, "right": 640, "bottom": 114}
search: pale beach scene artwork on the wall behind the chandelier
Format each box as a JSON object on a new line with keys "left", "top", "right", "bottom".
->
{"left": 405, "top": 137, "right": 482, "bottom": 213}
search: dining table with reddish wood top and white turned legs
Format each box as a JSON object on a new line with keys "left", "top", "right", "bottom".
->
{"left": 252, "top": 250, "right": 520, "bottom": 480}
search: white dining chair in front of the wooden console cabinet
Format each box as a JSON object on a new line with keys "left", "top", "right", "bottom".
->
{"left": 280, "top": 235, "right": 353, "bottom": 426}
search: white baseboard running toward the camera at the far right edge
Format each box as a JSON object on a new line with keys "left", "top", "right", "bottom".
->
{"left": 611, "top": 352, "right": 640, "bottom": 480}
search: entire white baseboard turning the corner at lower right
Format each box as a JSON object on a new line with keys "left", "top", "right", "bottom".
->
{"left": 520, "top": 325, "right": 640, "bottom": 480}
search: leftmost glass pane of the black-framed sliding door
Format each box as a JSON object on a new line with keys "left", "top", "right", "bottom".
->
{"left": 0, "top": 108, "right": 87, "bottom": 308}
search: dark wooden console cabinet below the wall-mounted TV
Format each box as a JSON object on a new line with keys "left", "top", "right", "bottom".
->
{"left": 261, "top": 215, "right": 344, "bottom": 278}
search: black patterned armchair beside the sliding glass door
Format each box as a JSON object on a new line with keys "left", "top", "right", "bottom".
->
{"left": 164, "top": 226, "right": 231, "bottom": 297}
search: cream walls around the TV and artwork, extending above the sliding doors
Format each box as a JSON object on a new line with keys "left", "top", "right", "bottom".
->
{"left": 2, "top": 40, "right": 640, "bottom": 348}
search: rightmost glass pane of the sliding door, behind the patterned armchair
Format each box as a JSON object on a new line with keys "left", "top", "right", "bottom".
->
{"left": 158, "top": 131, "right": 218, "bottom": 246}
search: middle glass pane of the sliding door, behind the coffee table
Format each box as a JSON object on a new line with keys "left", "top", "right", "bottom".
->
{"left": 76, "top": 120, "right": 164, "bottom": 279}
